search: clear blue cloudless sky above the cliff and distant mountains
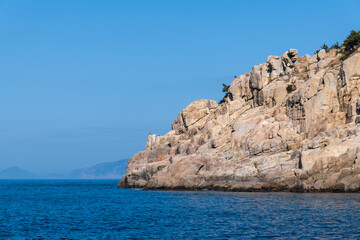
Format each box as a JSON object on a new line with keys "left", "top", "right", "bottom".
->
{"left": 0, "top": 0, "right": 360, "bottom": 174}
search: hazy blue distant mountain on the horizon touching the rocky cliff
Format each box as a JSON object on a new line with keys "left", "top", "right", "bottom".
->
{"left": 59, "top": 159, "right": 128, "bottom": 179}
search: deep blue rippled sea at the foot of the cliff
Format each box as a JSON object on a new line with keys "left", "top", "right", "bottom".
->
{"left": 0, "top": 180, "right": 360, "bottom": 239}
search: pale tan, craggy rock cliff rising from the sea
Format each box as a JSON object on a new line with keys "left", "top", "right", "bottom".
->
{"left": 119, "top": 49, "right": 360, "bottom": 191}
